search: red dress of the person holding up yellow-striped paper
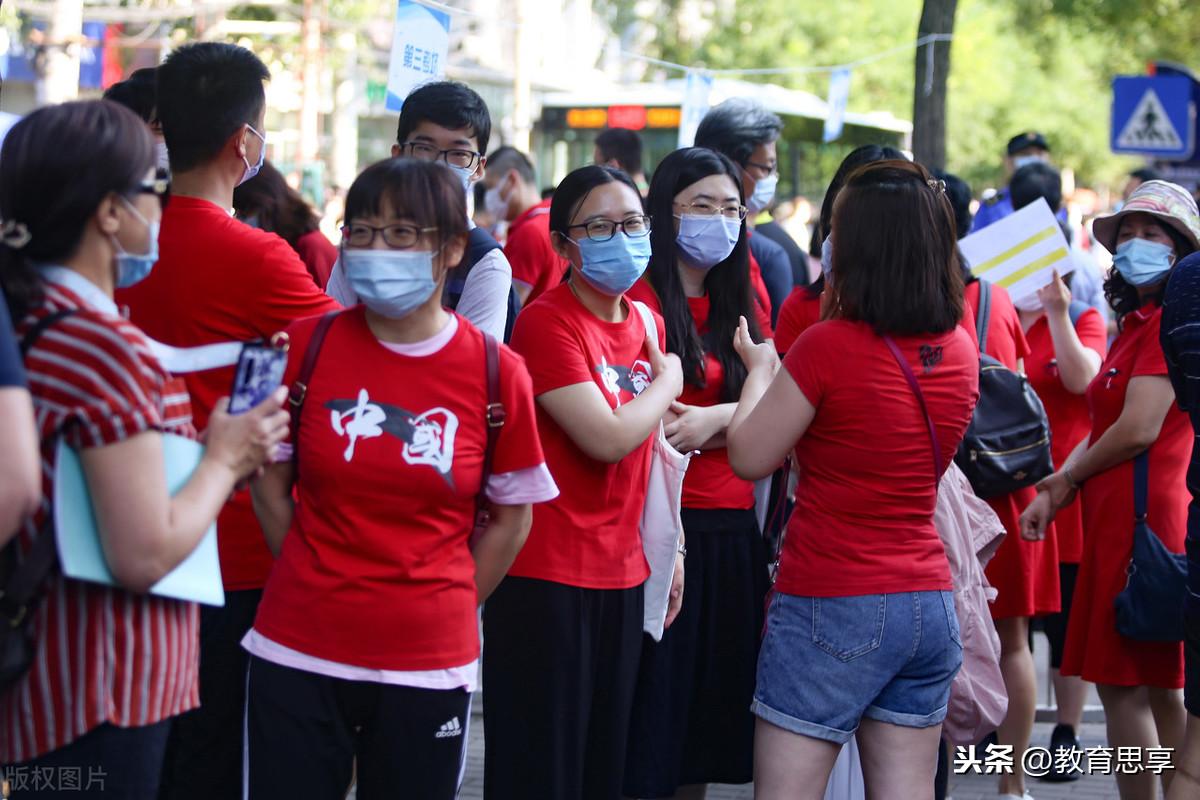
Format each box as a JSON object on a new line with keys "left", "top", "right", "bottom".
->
{"left": 1025, "top": 308, "right": 1108, "bottom": 564}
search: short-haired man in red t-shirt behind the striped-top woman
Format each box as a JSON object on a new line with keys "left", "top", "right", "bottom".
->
{"left": 118, "top": 42, "right": 337, "bottom": 800}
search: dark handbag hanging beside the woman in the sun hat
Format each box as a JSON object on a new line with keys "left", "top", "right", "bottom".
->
{"left": 1112, "top": 452, "right": 1188, "bottom": 642}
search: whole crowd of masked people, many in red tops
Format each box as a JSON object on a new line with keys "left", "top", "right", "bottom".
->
{"left": 0, "top": 42, "right": 1200, "bottom": 800}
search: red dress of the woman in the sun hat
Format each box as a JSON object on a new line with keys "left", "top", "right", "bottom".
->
{"left": 1062, "top": 306, "right": 1193, "bottom": 688}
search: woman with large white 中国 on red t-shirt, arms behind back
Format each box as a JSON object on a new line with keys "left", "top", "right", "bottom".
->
{"left": 244, "top": 158, "right": 558, "bottom": 800}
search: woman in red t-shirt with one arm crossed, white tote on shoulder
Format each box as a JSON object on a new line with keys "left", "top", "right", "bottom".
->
{"left": 484, "top": 167, "right": 683, "bottom": 800}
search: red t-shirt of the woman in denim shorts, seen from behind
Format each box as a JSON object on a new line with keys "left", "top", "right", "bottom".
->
{"left": 778, "top": 320, "right": 979, "bottom": 597}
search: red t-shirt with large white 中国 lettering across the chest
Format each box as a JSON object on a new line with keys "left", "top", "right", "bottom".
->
{"left": 254, "top": 306, "right": 545, "bottom": 670}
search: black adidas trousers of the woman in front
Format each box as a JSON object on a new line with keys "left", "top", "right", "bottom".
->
{"left": 246, "top": 657, "right": 470, "bottom": 800}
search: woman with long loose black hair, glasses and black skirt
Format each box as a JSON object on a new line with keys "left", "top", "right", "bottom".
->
{"left": 624, "top": 148, "right": 770, "bottom": 798}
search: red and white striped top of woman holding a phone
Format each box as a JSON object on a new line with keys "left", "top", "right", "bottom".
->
{"left": 0, "top": 269, "right": 199, "bottom": 763}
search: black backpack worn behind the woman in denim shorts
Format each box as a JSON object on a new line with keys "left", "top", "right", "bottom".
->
{"left": 954, "top": 281, "right": 1054, "bottom": 499}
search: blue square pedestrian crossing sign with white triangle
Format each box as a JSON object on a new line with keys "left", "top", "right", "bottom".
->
{"left": 1111, "top": 76, "right": 1196, "bottom": 160}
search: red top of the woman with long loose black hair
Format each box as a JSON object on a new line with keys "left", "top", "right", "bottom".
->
{"left": 628, "top": 279, "right": 770, "bottom": 509}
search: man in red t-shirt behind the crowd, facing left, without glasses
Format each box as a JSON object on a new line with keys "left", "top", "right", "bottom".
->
{"left": 484, "top": 146, "right": 566, "bottom": 307}
